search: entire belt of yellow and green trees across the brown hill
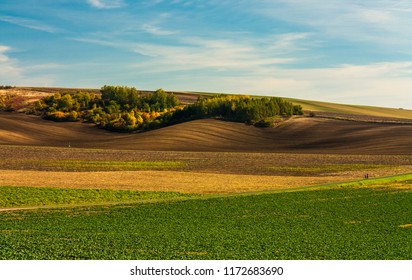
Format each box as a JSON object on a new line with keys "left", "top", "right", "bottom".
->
{"left": 33, "top": 86, "right": 303, "bottom": 131}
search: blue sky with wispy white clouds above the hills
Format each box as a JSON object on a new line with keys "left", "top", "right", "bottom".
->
{"left": 0, "top": 0, "right": 412, "bottom": 109}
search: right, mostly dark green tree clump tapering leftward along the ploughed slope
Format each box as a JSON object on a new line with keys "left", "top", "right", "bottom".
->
{"left": 169, "top": 95, "right": 303, "bottom": 126}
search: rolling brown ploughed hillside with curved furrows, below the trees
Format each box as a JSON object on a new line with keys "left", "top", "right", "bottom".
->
{"left": 0, "top": 113, "right": 412, "bottom": 154}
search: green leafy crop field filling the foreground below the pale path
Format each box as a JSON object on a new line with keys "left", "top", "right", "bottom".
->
{"left": 0, "top": 174, "right": 412, "bottom": 259}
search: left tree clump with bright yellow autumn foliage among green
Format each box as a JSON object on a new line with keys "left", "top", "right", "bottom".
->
{"left": 34, "top": 86, "right": 183, "bottom": 131}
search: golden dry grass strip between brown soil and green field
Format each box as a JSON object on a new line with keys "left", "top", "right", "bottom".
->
{"left": 0, "top": 170, "right": 348, "bottom": 194}
